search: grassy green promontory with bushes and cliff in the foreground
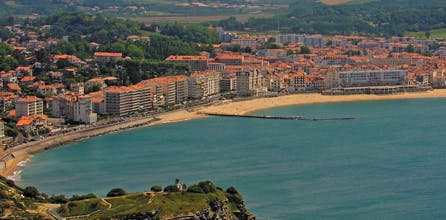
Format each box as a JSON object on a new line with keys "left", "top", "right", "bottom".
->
{"left": 0, "top": 177, "right": 255, "bottom": 219}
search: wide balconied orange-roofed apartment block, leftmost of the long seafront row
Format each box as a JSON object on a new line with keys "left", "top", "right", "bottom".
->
{"left": 105, "top": 83, "right": 152, "bottom": 116}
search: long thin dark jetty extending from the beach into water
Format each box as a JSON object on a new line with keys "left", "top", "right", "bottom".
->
{"left": 200, "top": 112, "right": 356, "bottom": 121}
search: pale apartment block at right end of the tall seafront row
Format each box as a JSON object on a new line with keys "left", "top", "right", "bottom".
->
{"left": 236, "top": 69, "right": 267, "bottom": 95}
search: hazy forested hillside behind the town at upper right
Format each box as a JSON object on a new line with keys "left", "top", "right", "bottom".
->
{"left": 218, "top": 0, "right": 446, "bottom": 36}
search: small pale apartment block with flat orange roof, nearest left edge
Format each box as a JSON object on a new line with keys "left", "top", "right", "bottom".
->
{"left": 15, "top": 96, "right": 43, "bottom": 117}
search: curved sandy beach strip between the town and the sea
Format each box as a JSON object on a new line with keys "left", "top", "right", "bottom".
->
{"left": 0, "top": 89, "right": 446, "bottom": 177}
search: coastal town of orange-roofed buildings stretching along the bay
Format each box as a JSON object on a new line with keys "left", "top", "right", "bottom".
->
{"left": 0, "top": 18, "right": 446, "bottom": 150}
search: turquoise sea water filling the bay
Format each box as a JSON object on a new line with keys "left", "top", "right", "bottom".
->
{"left": 15, "top": 99, "right": 446, "bottom": 219}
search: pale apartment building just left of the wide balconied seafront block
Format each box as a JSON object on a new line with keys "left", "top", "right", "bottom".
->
{"left": 52, "top": 92, "right": 97, "bottom": 124}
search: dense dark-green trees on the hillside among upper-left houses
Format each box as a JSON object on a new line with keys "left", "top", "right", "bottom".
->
{"left": 23, "top": 13, "right": 218, "bottom": 84}
